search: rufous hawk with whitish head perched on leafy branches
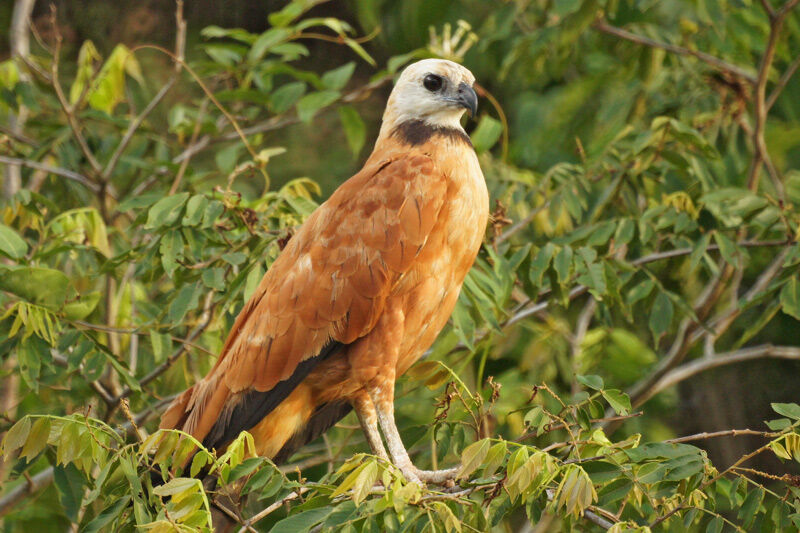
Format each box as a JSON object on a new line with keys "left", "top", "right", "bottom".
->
{"left": 161, "top": 59, "right": 489, "bottom": 483}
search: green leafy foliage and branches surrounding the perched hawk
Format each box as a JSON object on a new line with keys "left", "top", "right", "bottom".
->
{"left": 0, "top": 0, "right": 800, "bottom": 531}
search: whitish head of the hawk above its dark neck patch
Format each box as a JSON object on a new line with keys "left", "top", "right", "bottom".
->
{"left": 381, "top": 59, "right": 478, "bottom": 135}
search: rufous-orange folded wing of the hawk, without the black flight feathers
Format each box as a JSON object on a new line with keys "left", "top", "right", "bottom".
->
{"left": 162, "top": 155, "right": 447, "bottom": 445}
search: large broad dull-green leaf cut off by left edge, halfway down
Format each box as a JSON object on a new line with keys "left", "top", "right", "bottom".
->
{"left": 0, "top": 265, "right": 69, "bottom": 309}
